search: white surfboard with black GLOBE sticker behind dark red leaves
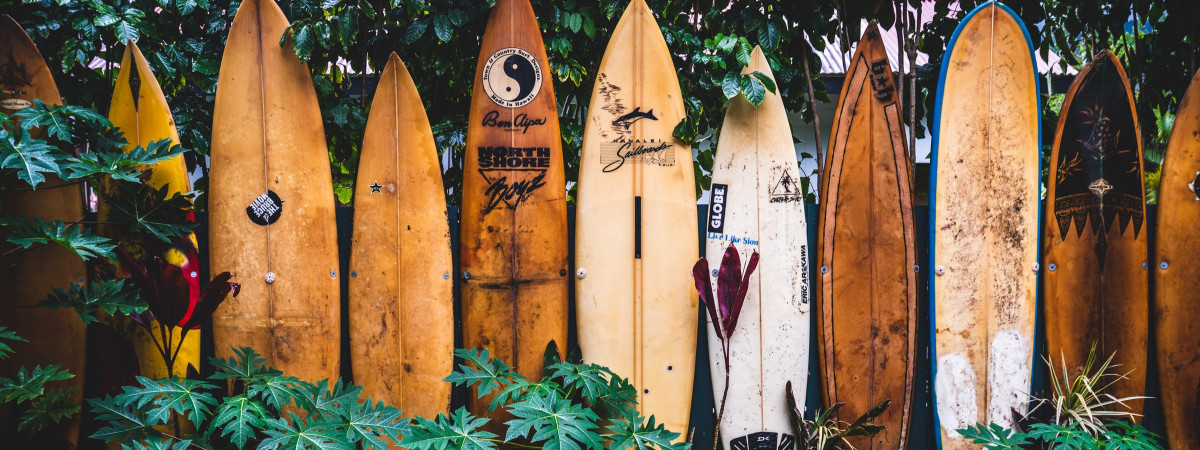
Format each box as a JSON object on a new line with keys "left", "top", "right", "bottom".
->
{"left": 706, "top": 47, "right": 811, "bottom": 449}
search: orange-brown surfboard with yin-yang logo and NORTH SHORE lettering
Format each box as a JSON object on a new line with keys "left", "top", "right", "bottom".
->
{"left": 460, "top": 0, "right": 570, "bottom": 415}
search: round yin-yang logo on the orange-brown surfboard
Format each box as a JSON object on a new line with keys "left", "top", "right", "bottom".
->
{"left": 482, "top": 47, "right": 541, "bottom": 108}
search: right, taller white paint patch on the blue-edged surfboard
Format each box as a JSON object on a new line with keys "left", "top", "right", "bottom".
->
{"left": 988, "top": 328, "right": 1032, "bottom": 427}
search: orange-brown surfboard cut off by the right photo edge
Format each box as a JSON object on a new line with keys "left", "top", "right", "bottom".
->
{"left": 1150, "top": 68, "right": 1200, "bottom": 449}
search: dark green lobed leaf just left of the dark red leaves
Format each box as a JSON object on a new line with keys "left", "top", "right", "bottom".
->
{"left": 37, "top": 280, "right": 148, "bottom": 325}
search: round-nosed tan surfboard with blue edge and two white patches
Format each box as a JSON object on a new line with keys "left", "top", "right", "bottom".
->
{"left": 929, "top": 2, "right": 1042, "bottom": 449}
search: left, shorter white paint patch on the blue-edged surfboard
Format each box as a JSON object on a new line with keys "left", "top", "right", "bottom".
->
{"left": 934, "top": 353, "right": 979, "bottom": 439}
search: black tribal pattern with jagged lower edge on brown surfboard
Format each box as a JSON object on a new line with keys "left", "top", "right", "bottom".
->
{"left": 1054, "top": 58, "right": 1145, "bottom": 266}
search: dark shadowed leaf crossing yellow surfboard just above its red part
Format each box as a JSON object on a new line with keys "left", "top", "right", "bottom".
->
{"left": 101, "top": 182, "right": 199, "bottom": 242}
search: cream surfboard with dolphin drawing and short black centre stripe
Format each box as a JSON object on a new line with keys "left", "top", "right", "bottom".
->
{"left": 575, "top": 0, "right": 700, "bottom": 436}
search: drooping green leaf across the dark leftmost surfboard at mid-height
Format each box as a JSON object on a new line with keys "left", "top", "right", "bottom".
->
{"left": 0, "top": 216, "right": 116, "bottom": 260}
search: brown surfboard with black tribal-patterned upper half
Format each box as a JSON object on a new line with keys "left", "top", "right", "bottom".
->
{"left": 1043, "top": 50, "right": 1147, "bottom": 414}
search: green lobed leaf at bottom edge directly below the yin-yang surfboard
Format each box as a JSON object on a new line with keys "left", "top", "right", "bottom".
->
{"left": 504, "top": 391, "right": 602, "bottom": 450}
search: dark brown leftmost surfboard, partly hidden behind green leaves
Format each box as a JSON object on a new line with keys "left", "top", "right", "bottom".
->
{"left": 0, "top": 14, "right": 88, "bottom": 448}
